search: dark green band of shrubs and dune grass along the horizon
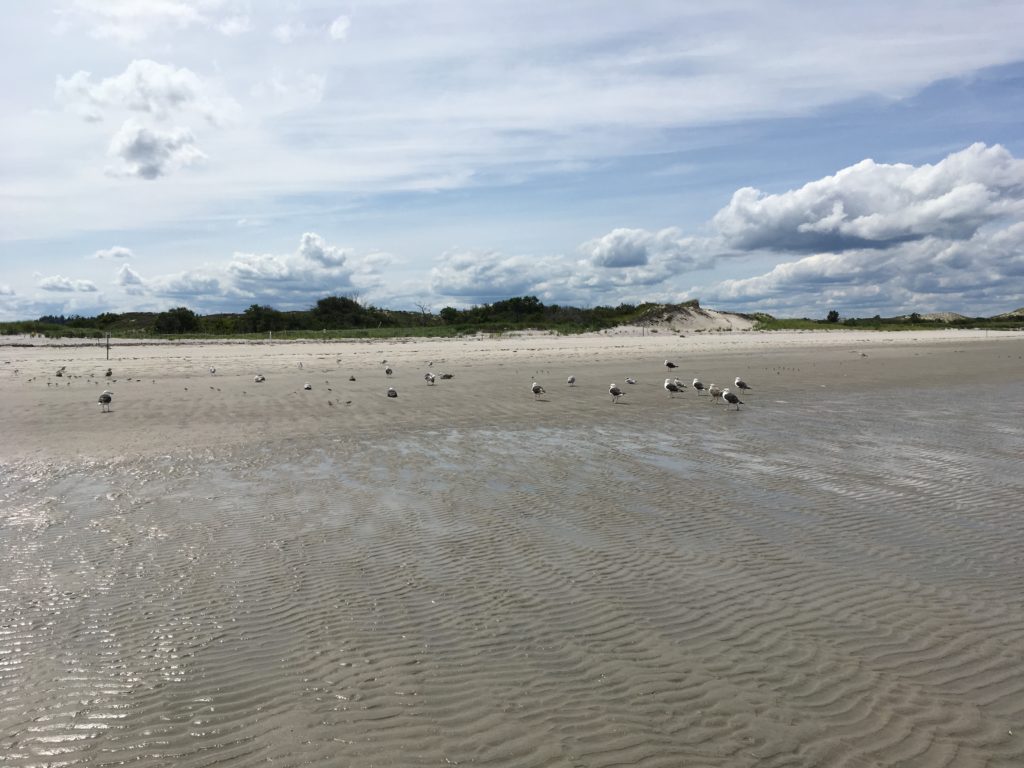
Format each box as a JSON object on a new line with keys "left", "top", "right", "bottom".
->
{"left": 0, "top": 296, "right": 1024, "bottom": 340}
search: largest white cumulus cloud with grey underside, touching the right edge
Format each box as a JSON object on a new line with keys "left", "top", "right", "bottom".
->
{"left": 713, "top": 143, "right": 1024, "bottom": 253}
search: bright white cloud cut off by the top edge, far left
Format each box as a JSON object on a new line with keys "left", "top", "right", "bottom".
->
{"left": 63, "top": 0, "right": 247, "bottom": 43}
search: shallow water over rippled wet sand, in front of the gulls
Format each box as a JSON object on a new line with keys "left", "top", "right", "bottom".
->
{"left": 0, "top": 387, "right": 1024, "bottom": 766}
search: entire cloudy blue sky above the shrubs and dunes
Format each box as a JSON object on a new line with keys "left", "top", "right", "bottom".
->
{"left": 0, "top": 0, "right": 1024, "bottom": 319}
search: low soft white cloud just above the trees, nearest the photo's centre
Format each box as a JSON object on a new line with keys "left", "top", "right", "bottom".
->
{"left": 430, "top": 251, "right": 571, "bottom": 303}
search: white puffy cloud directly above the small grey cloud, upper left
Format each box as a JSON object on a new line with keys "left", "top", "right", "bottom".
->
{"left": 55, "top": 58, "right": 237, "bottom": 124}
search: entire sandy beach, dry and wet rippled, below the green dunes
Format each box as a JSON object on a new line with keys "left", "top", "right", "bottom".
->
{"left": 0, "top": 331, "right": 1024, "bottom": 766}
